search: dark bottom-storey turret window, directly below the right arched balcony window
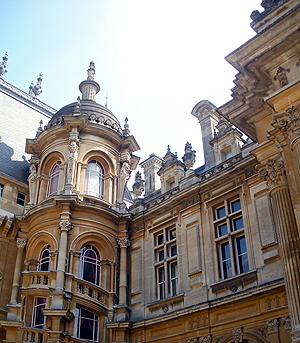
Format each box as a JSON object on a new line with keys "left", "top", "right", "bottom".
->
{"left": 74, "top": 305, "right": 99, "bottom": 343}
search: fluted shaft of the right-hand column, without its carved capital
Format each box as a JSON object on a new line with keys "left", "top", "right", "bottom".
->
{"left": 271, "top": 187, "right": 300, "bottom": 327}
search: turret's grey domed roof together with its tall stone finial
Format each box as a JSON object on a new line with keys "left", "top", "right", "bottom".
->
{"left": 46, "top": 61, "right": 123, "bottom": 134}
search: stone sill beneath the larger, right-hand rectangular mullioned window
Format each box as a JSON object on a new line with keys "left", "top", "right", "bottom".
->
{"left": 210, "top": 269, "right": 257, "bottom": 293}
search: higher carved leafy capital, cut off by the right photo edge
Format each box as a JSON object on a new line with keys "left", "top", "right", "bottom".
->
{"left": 271, "top": 102, "right": 300, "bottom": 143}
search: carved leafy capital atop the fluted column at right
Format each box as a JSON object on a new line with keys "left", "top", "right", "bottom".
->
{"left": 256, "top": 158, "right": 287, "bottom": 190}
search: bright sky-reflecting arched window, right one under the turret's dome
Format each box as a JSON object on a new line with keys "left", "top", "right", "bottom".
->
{"left": 84, "top": 160, "right": 104, "bottom": 199}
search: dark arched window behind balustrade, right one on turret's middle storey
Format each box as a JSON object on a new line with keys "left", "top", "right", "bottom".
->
{"left": 78, "top": 244, "right": 100, "bottom": 286}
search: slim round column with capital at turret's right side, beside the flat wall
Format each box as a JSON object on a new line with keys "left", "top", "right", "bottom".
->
{"left": 117, "top": 237, "right": 130, "bottom": 305}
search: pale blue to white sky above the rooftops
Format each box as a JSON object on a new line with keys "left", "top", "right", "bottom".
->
{"left": 0, "top": 0, "right": 262, "bottom": 180}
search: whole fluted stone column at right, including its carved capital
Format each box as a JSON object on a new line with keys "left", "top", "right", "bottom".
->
{"left": 257, "top": 155, "right": 300, "bottom": 342}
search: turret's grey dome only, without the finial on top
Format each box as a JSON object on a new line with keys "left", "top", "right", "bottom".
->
{"left": 47, "top": 100, "right": 122, "bottom": 134}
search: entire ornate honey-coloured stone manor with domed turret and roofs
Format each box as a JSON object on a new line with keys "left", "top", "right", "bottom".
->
{"left": 0, "top": 0, "right": 300, "bottom": 343}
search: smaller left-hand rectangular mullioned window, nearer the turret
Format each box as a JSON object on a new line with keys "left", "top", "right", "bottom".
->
{"left": 154, "top": 228, "right": 178, "bottom": 300}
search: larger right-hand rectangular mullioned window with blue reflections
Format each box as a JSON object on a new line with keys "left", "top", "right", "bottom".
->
{"left": 214, "top": 199, "right": 249, "bottom": 279}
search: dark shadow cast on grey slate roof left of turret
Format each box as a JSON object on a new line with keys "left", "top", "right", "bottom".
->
{"left": 0, "top": 139, "right": 29, "bottom": 184}
